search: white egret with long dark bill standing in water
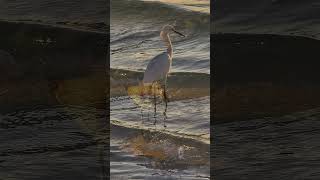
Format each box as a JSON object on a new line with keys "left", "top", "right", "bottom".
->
{"left": 142, "top": 25, "right": 185, "bottom": 127}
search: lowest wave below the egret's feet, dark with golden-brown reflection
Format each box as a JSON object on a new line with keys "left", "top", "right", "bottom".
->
{"left": 111, "top": 122, "right": 210, "bottom": 172}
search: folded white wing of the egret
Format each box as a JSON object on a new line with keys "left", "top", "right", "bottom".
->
{"left": 143, "top": 52, "right": 171, "bottom": 83}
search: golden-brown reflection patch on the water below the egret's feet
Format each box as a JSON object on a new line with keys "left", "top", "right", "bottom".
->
{"left": 122, "top": 133, "right": 210, "bottom": 169}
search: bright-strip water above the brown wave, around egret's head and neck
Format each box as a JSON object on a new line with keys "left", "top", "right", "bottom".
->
{"left": 110, "top": 0, "right": 210, "bottom": 73}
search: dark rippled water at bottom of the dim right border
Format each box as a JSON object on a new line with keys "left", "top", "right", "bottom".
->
{"left": 212, "top": 108, "right": 320, "bottom": 179}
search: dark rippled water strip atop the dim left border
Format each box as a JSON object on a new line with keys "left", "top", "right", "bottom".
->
{"left": 0, "top": 0, "right": 109, "bottom": 32}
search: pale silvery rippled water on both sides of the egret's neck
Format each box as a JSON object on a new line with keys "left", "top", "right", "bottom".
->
{"left": 110, "top": 28, "right": 210, "bottom": 74}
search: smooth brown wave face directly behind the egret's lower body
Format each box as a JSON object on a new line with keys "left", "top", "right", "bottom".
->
{"left": 110, "top": 69, "right": 210, "bottom": 100}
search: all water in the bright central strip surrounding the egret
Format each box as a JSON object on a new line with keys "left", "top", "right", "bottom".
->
{"left": 110, "top": 0, "right": 210, "bottom": 179}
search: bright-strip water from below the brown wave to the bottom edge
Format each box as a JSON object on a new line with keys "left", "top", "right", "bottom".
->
{"left": 110, "top": 89, "right": 210, "bottom": 179}
